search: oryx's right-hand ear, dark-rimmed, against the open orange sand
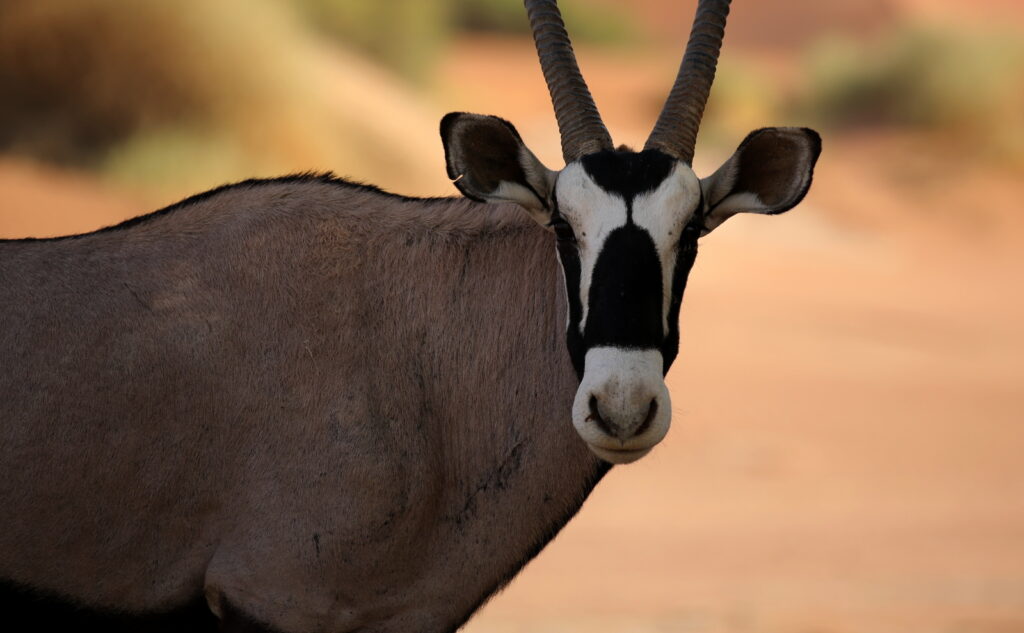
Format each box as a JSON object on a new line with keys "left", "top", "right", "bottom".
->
{"left": 700, "top": 127, "right": 821, "bottom": 235}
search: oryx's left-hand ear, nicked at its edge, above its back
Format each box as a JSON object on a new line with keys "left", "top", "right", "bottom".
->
{"left": 441, "top": 112, "right": 557, "bottom": 224}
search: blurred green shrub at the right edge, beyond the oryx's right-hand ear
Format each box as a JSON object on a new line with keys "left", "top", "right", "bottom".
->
{"left": 800, "top": 26, "right": 1024, "bottom": 161}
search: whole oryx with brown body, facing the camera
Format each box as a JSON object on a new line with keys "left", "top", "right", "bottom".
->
{"left": 0, "top": 0, "right": 820, "bottom": 633}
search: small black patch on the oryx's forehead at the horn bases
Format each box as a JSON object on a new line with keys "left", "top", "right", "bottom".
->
{"left": 580, "top": 150, "right": 676, "bottom": 201}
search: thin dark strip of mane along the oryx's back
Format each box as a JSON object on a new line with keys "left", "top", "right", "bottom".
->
{"left": 0, "top": 171, "right": 451, "bottom": 244}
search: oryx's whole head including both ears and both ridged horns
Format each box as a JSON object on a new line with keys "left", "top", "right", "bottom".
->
{"left": 441, "top": 0, "right": 821, "bottom": 463}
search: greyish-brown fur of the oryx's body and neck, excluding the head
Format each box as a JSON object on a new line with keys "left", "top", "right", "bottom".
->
{"left": 0, "top": 176, "right": 603, "bottom": 632}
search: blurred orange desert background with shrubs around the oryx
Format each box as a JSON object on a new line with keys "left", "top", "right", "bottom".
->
{"left": 0, "top": 0, "right": 1024, "bottom": 633}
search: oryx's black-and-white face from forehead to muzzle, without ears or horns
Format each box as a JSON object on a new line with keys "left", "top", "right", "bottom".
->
{"left": 552, "top": 150, "right": 702, "bottom": 463}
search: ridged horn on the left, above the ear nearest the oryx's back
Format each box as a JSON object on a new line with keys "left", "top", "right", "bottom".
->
{"left": 523, "top": 0, "right": 612, "bottom": 163}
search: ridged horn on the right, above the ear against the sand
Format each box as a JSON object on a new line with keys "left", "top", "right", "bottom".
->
{"left": 644, "top": 0, "right": 730, "bottom": 165}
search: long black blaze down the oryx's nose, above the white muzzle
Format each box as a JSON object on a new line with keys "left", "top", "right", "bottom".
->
{"left": 584, "top": 224, "right": 665, "bottom": 349}
